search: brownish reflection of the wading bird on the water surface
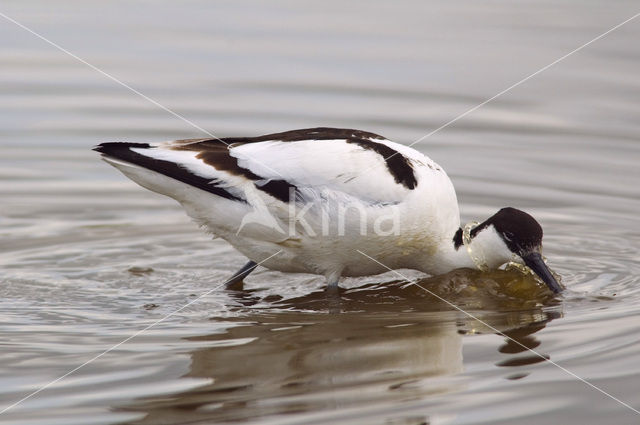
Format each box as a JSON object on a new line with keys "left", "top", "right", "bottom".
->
{"left": 118, "top": 270, "right": 561, "bottom": 425}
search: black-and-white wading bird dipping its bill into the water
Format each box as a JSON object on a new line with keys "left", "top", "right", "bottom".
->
{"left": 93, "top": 127, "right": 563, "bottom": 293}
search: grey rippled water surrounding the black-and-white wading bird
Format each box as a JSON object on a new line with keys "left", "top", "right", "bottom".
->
{"left": 0, "top": 1, "right": 640, "bottom": 425}
